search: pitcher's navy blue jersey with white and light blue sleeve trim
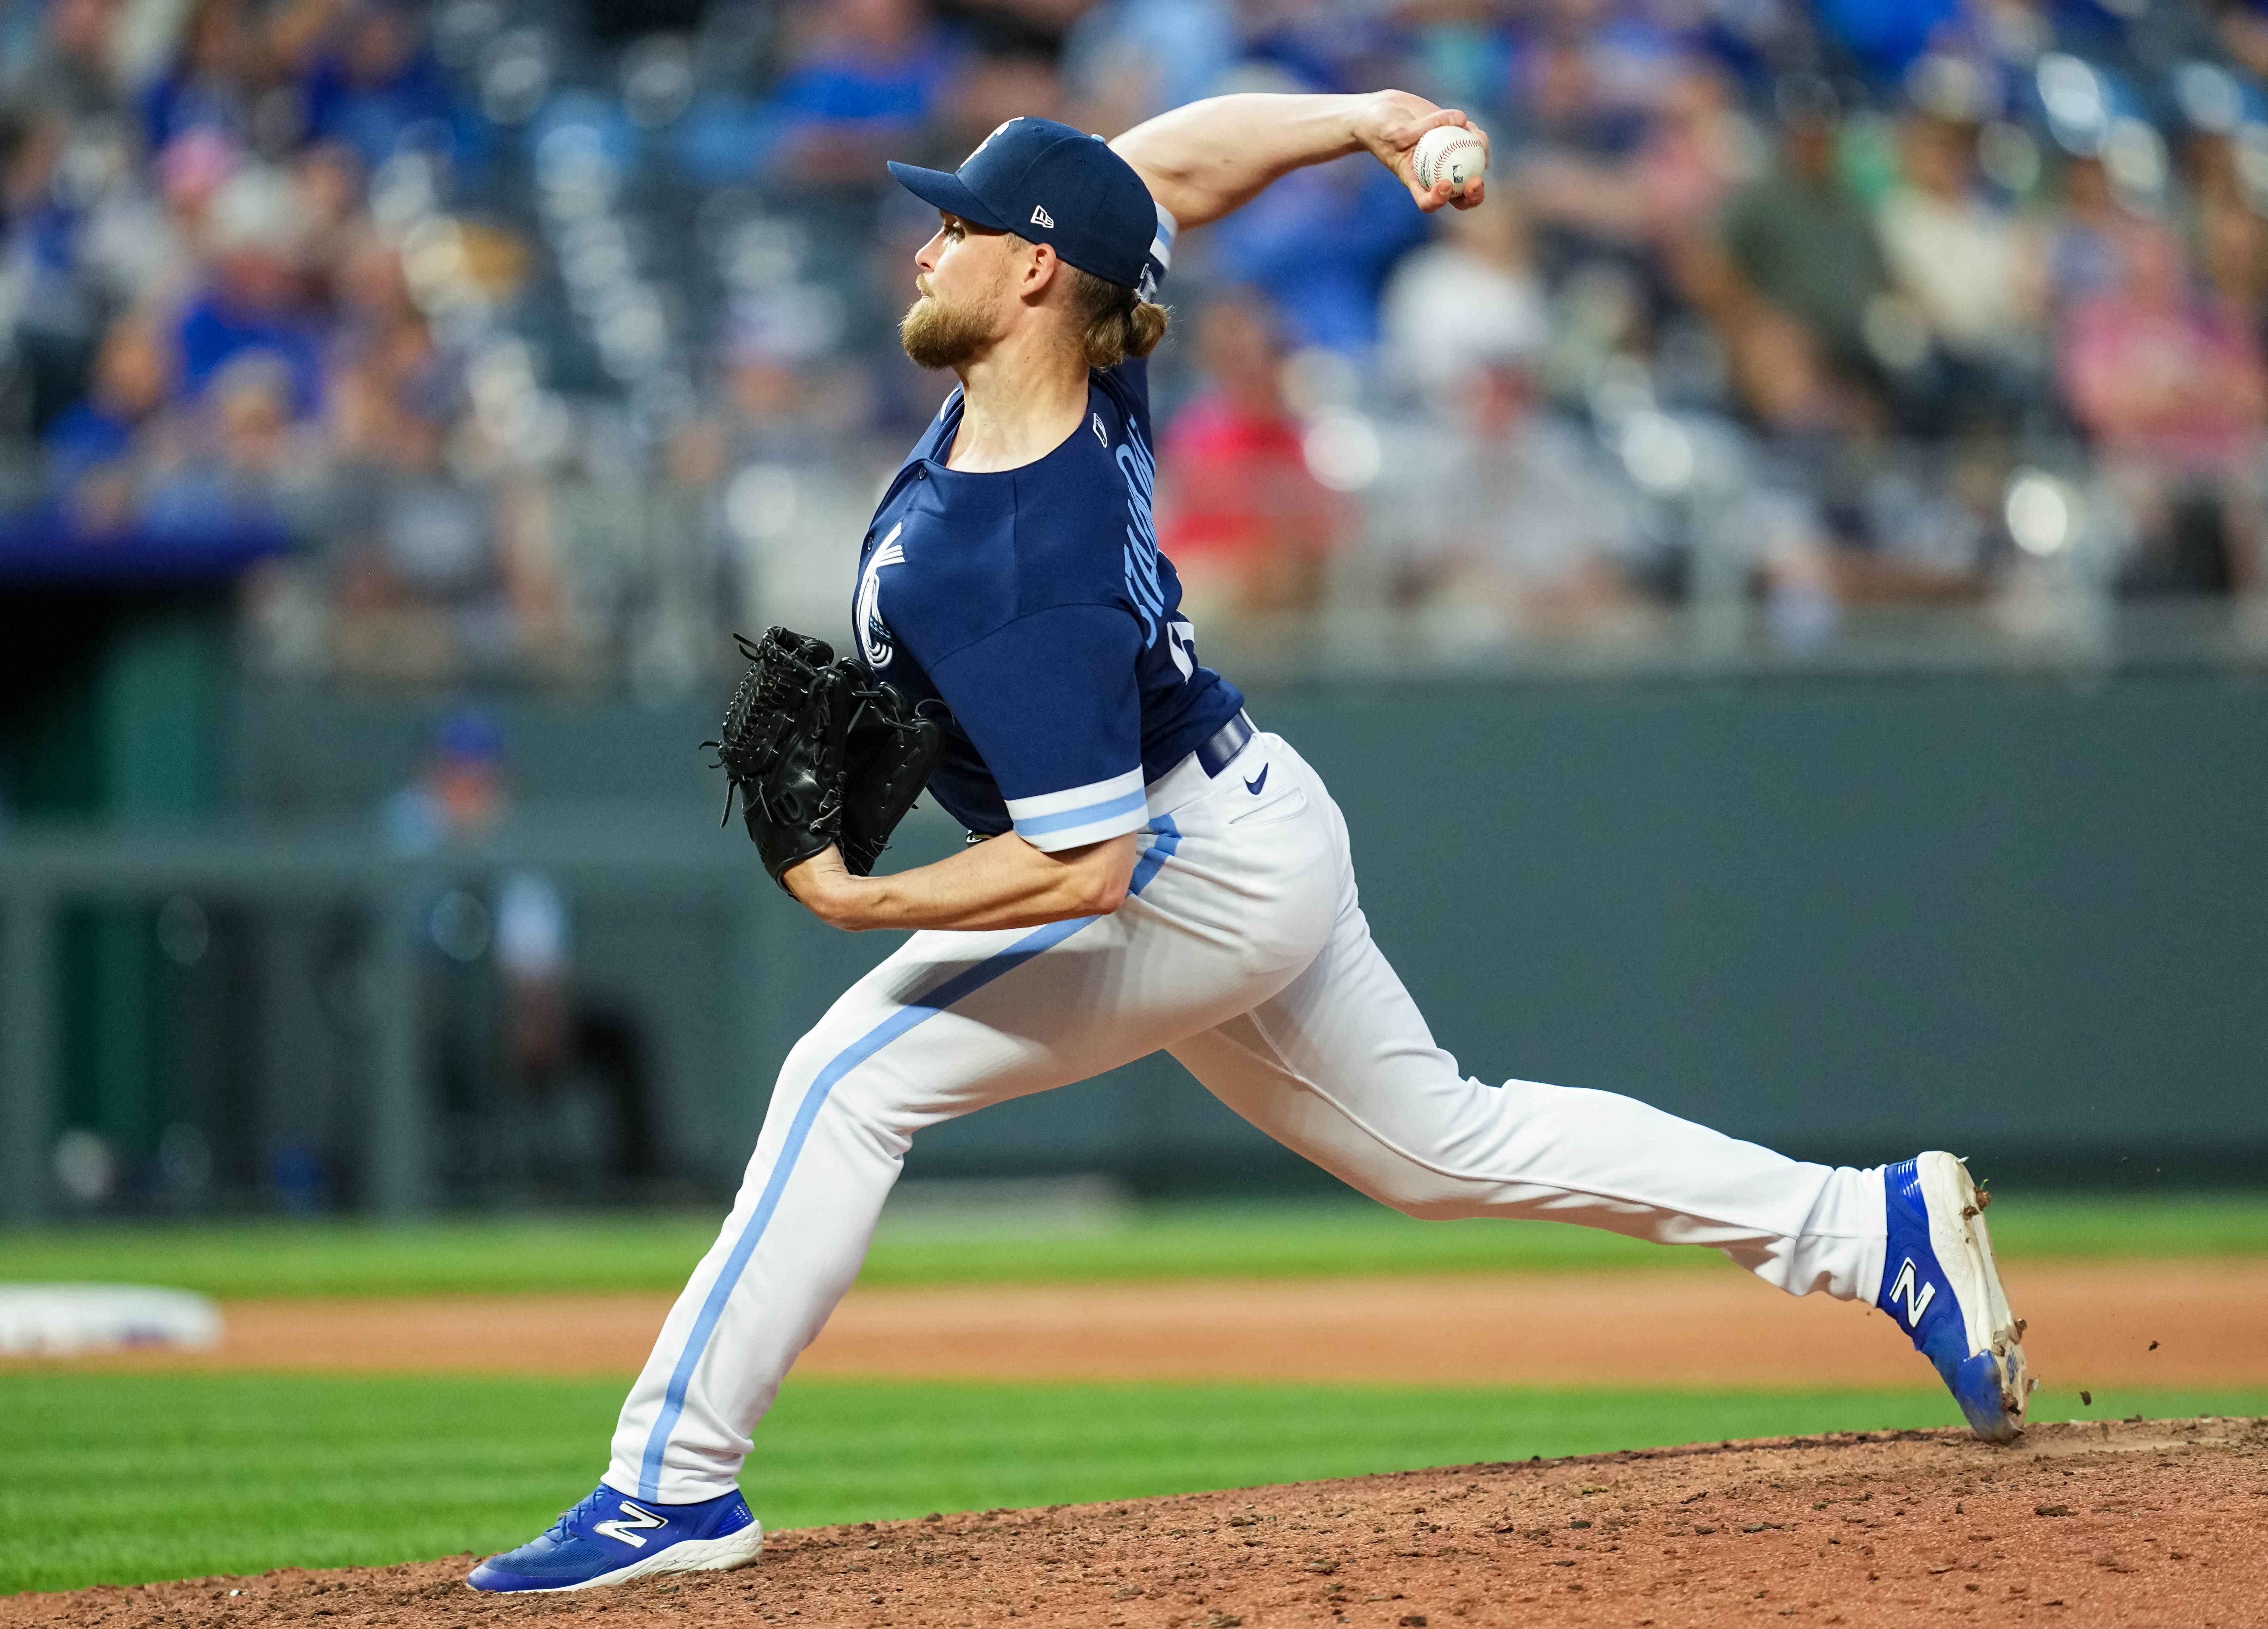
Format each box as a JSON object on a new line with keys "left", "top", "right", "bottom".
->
{"left": 851, "top": 361, "right": 1243, "bottom": 848}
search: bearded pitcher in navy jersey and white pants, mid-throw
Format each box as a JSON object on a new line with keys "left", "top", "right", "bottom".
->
{"left": 467, "top": 91, "right": 2025, "bottom": 1590}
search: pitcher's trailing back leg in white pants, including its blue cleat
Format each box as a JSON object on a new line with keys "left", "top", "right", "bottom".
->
{"left": 1173, "top": 905, "right": 2030, "bottom": 1441}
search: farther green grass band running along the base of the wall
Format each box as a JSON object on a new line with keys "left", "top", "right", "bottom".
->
{"left": 0, "top": 1193, "right": 2268, "bottom": 1300}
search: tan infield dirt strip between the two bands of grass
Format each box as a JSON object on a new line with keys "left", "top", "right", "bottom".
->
{"left": 40, "top": 1261, "right": 2268, "bottom": 1388}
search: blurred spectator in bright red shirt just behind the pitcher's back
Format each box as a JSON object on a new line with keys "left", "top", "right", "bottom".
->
{"left": 1159, "top": 293, "right": 1343, "bottom": 624}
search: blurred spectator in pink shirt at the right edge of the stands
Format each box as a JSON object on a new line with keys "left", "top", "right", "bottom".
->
{"left": 2059, "top": 229, "right": 2268, "bottom": 592}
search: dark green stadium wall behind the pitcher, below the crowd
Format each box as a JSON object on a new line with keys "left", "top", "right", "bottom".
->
{"left": 221, "top": 674, "right": 2268, "bottom": 1189}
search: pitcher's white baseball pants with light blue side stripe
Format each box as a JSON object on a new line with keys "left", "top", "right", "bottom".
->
{"left": 605, "top": 733, "right": 1885, "bottom": 1504}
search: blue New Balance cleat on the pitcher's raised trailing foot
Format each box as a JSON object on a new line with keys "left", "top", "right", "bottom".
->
{"left": 1874, "top": 1153, "right": 2032, "bottom": 1443}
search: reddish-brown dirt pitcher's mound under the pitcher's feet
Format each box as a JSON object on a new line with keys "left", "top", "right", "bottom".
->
{"left": 0, "top": 1420, "right": 2268, "bottom": 1629}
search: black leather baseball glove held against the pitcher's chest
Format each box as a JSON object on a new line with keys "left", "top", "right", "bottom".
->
{"left": 703, "top": 629, "right": 944, "bottom": 887}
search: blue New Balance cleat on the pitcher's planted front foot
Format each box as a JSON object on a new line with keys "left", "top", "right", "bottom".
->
{"left": 465, "top": 1482, "right": 764, "bottom": 1590}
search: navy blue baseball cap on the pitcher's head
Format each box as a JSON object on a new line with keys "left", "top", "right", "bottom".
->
{"left": 889, "top": 118, "right": 1173, "bottom": 300}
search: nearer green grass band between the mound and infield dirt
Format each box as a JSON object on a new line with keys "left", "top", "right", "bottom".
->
{"left": 0, "top": 1373, "right": 2268, "bottom": 1593}
